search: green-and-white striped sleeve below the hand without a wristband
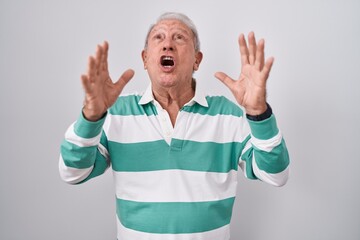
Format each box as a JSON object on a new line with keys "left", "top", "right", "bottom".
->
{"left": 59, "top": 114, "right": 110, "bottom": 184}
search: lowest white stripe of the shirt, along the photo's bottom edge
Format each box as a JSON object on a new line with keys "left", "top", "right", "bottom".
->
{"left": 117, "top": 218, "right": 230, "bottom": 240}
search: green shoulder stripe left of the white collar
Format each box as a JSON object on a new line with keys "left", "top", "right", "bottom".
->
{"left": 109, "top": 95, "right": 157, "bottom": 116}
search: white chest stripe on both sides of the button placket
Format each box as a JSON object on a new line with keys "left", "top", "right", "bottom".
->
{"left": 104, "top": 111, "right": 250, "bottom": 143}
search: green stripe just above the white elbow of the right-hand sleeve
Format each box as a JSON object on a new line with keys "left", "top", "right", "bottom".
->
{"left": 254, "top": 139, "right": 290, "bottom": 174}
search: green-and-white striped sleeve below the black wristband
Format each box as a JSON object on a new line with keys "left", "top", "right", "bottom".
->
{"left": 239, "top": 115, "right": 290, "bottom": 186}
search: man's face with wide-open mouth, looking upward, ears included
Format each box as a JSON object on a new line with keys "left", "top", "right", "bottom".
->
{"left": 142, "top": 20, "right": 202, "bottom": 87}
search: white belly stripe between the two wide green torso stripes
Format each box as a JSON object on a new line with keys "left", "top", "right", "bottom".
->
{"left": 114, "top": 170, "right": 237, "bottom": 202}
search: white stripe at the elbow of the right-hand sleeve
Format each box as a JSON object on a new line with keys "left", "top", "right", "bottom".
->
{"left": 252, "top": 156, "right": 289, "bottom": 187}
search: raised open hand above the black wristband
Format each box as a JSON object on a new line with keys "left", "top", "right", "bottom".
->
{"left": 215, "top": 32, "right": 274, "bottom": 115}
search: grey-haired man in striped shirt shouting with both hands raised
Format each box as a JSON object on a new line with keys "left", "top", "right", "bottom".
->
{"left": 59, "top": 13, "right": 289, "bottom": 240}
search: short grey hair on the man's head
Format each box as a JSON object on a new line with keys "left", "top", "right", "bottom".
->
{"left": 144, "top": 12, "right": 200, "bottom": 52}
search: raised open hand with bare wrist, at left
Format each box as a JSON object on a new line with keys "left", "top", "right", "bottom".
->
{"left": 81, "top": 42, "right": 134, "bottom": 121}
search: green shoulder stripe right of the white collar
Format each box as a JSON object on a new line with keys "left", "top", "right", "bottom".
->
{"left": 183, "top": 96, "right": 243, "bottom": 117}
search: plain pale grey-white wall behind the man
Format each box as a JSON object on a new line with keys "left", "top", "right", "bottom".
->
{"left": 0, "top": 0, "right": 360, "bottom": 240}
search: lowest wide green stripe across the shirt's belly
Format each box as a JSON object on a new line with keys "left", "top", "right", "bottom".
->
{"left": 116, "top": 197, "right": 235, "bottom": 234}
